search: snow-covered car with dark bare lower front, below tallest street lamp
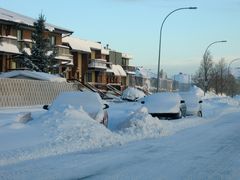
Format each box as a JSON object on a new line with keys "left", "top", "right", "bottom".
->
{"left": 139, "top": 92, "right": 186, "bottom": 119}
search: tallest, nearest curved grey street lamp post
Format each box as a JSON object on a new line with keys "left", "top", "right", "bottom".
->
{"left": 157, "top": 7, "right": 197, "bottom": 92}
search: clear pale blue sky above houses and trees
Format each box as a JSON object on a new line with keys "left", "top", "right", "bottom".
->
{"left": 0, "top": 0, "right": 240, "bottom": 75}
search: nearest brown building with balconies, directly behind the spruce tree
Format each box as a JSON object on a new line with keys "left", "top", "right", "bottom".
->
{"left": 0, "top": 8, "right": 73, "bottom": 78}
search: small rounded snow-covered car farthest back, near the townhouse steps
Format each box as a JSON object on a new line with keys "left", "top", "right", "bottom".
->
{"left": 122, "top": 87, "right": 145, "bottom": 101}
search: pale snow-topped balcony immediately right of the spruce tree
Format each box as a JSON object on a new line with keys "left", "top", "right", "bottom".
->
{"left": 55, "top": 45, "right": 73, "bottom": 65}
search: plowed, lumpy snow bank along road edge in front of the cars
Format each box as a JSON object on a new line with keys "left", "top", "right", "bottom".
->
{"left": 0, "top": 107, "right": 205, "bottom": 166}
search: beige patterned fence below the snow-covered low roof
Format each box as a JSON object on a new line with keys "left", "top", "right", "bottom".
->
{"left": 0, "top": 78, "right": 79, "bottom": 108}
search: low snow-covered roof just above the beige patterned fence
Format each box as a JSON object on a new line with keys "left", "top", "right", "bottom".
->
{"left": 0, "top": 70, "right": 66, "bottom": 82}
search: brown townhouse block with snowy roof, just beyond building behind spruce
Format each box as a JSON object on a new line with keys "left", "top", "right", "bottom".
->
{"left": 63, "top": 36, "right": 134, "bottom": 91}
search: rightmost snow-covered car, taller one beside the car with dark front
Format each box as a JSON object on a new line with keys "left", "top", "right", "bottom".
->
{"left": 179, "top": 86, "right": 203, "bottom": 117}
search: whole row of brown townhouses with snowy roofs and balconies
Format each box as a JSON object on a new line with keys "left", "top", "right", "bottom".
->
{"left": 0, "top": 8, "right": 136, "bottom": 90}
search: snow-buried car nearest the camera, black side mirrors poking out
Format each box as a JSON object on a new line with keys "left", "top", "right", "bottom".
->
{"left": 43, "top": 91, "right": 109, "bottom": 127}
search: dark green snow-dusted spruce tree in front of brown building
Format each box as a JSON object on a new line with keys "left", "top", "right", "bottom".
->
{"left": 30, "top": 14, "right": 54, "bottom": 72}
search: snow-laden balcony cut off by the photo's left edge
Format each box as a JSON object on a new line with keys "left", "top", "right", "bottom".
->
{"left": 0, "top": 36, "right": 21, "bottom": 54}
